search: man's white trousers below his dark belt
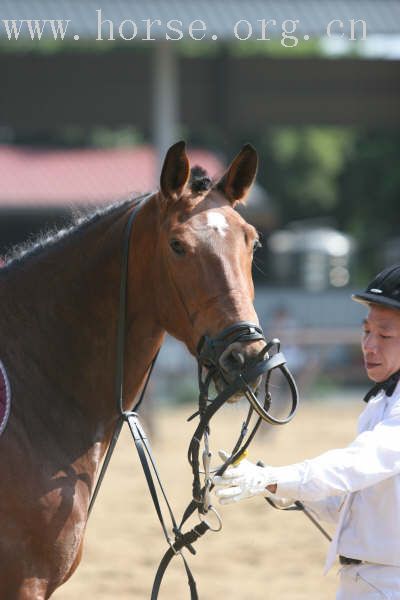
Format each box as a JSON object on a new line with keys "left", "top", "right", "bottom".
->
{"left": 336, "top": 563, "right": 400, "bottom": 600}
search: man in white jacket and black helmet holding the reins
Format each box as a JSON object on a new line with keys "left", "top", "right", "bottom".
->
{"left": 214, "top": 265, "right": 400, "bottom": 600}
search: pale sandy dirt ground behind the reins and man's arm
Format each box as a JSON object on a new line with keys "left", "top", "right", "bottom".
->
{"left": 53, "top": 400, "right": 362, "bottom": 600}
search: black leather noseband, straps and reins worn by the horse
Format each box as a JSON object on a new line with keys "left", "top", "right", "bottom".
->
{"left": 88, "top": 194, "right": 298, "bottom": 600}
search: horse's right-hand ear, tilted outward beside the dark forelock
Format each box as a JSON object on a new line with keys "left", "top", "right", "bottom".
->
{"left": 217, "top": 144, "right": 258, "bottom": 205}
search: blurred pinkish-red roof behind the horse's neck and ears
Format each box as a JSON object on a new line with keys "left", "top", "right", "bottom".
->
{"left": 0, "top": 146, "right": 223, "bottom": 207}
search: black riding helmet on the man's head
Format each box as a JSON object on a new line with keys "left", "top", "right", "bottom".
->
{"left": 352, "top": 265, "right": 400, "bottom": 310}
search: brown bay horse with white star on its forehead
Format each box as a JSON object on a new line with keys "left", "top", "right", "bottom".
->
{"left": 0, "top": 142, "right": 264, "bottom": 600}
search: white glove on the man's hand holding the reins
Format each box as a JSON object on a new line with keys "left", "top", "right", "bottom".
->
{"left": 213, "top": 451, "right": 276, "bottom": 504}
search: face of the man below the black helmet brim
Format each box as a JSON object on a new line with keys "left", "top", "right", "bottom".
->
{"left": 362, "top": 304, "right": 400, "bottom": 382}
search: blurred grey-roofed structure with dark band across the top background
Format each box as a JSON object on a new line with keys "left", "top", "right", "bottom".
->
{"left": 0, "top": 0, "right": 400, "bottom": 155}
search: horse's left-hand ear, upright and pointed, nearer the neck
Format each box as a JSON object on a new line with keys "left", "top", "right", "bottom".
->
{"left": 160, "top": 142, "right": 190, "bottom": 200}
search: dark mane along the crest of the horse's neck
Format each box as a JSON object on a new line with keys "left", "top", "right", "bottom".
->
{"left": 0, "top": 197, "right": 140, "bottom": 273}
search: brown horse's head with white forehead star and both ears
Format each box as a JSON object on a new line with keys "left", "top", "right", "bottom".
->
{"left": 155, "top": 142, "right": 265, "bottom": 398}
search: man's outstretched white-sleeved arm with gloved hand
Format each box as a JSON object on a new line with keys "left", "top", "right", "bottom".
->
{"left": 215, "top": 414, "right": 400, "bottom": 503}
